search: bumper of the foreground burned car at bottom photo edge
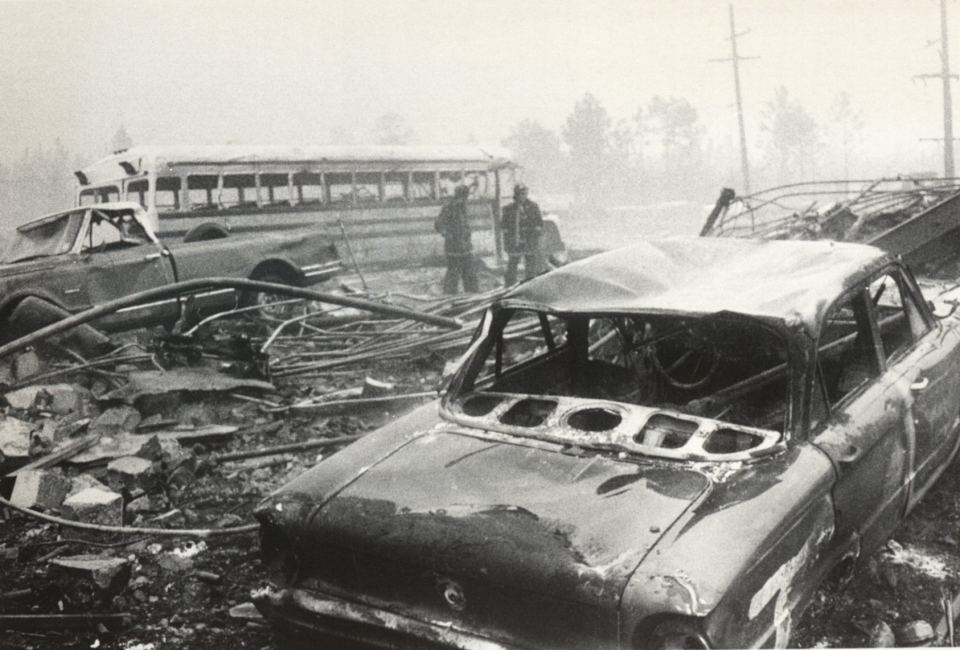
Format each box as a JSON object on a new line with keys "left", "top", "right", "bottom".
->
{"left": 253, "top": 588, "right": 521, "bottom": 650}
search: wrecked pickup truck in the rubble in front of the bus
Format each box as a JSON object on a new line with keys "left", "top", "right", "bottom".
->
{"left": 0, "top": 203, "right": 340, "bottom": 335}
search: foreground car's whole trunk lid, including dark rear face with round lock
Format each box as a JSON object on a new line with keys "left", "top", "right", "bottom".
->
{"left": 309, "top": 432, "right": 708, "bottom": 647}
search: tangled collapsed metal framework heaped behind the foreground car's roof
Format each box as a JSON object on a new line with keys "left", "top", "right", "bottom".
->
{"left": 701, "top": 176, "right": 960, "bottom": 264}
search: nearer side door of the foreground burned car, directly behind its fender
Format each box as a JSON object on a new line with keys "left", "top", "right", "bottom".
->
{"left": 811, "top": 285, "right": 913, "bottom": 552}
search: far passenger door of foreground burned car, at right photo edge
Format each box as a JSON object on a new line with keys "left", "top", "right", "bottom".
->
{"left": 871, "top": 267, "right": 960, "bottom": 510}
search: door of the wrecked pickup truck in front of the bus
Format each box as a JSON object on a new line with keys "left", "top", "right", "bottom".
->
{"left": 80, "top": 210, "right": 178, "bottom": 327}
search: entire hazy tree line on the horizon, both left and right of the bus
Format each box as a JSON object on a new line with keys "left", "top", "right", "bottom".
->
{"left": 0, "top": 87, "right": 872, "bottom": 226}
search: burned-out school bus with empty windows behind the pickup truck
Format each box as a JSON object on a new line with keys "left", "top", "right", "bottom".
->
{"left": 75, "top": 145, "right": 516, "bottom": 266}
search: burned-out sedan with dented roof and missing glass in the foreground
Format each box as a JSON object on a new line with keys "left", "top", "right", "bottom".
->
{"left": 257, "top": 238, "right": 960, "bottom": 650}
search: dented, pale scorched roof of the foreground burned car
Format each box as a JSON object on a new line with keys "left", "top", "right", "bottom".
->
{"left": 499, "top": 237, "right": 891, "bottom": 336}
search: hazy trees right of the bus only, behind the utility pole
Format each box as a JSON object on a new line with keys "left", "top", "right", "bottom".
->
{"left": 503, "top": 87, "right": 863, "bottom": 208}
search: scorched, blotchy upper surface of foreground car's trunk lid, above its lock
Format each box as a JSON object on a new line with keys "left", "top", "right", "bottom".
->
{"left": 308, "top": 429, "right": 709, "bottom": 608}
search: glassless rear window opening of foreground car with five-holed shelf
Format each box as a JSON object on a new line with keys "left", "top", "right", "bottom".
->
{"left": 451, "top": 310, "right": 789, "bottom": 458}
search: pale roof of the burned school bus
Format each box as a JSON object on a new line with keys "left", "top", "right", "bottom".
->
{"left": 77, "top": 145, "right": 511, "bottom": 185}
